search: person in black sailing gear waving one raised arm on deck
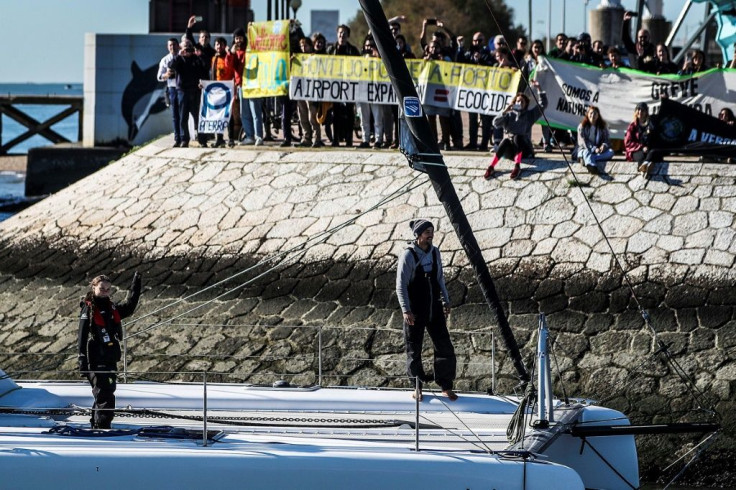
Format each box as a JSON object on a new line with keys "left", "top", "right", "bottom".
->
{"left": 77, "top": 272, "right": 141, "bottom": 429}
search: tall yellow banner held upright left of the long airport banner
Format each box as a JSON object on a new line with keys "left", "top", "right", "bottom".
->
{"left": 242, "top": 20, "right": 289, "bottom": 99}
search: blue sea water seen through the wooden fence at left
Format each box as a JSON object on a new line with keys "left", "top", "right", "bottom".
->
{"left": 0, "top": 83, "right": 83, "bottom": 154}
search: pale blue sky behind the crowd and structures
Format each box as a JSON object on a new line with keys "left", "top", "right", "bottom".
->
{"left": 0, "top": 0, "right": 703, "bottom": 83}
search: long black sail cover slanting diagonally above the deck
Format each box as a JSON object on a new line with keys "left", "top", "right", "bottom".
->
{"left": 360, "top": 0, "right": 529, "bottom": 382}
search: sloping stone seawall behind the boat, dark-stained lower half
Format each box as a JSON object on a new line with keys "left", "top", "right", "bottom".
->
{"left": 0, "top": 137, "right": 736, "bottom": 482}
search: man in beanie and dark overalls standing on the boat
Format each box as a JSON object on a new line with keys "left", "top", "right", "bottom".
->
{"left": 396, "top": 219, "right": 457, "bottom": 401}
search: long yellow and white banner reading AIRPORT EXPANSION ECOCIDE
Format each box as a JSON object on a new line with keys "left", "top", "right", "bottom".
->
{"left": 289, "top": 55, "right": 521, "bottom": 115}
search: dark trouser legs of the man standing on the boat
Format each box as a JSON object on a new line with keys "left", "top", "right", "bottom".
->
{"left": 404, "top": 309, "right": 457, "bottom": 390}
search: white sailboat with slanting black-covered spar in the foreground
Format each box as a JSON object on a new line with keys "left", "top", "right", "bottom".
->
{"left": 0, "top": 0, "right": 720, "bottom": 490}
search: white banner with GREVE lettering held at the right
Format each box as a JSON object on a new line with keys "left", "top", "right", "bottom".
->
{"left": 535, "top": 58, "right": 736, "bottom": 139}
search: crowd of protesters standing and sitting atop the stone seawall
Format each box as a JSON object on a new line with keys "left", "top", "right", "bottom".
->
{"left": 158, "top": 12, "right": 735, "bottom": 178}
